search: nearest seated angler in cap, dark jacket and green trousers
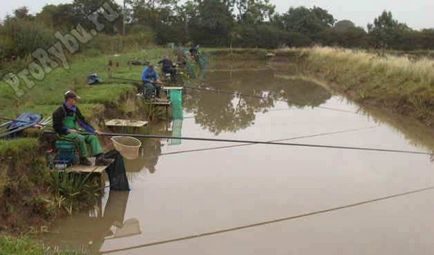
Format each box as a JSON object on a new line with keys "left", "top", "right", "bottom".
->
{"left": 53, "top": 91, "right": 110, "bottom": 166}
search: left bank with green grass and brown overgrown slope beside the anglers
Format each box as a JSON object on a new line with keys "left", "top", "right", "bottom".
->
{"left": 0, "top": 46, "right": 171, "bottom": 236}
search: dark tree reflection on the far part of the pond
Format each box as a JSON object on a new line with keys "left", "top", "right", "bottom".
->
{"left": 185, "top": 69, "right": 332, "bottom": 135}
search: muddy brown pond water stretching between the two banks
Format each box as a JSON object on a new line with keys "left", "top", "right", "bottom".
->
{"left": 42, "top": 58, "right": 434, "bottom": 255}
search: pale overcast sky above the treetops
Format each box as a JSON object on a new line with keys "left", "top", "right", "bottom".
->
{"left": 0, "top": 0, "right": 434, "bottom": 29}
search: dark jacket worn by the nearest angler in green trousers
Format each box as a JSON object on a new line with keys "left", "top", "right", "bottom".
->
{"left": 53, "top": 104, "right": 95, "bottom": 135}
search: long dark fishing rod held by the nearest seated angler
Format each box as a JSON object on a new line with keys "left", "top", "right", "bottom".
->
{"left": 98, "top": 133, "right": 432, "bottom": 156}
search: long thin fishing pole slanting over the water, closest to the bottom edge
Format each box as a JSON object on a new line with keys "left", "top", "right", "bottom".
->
{"left": 101, "top": 186, "right": 434, "bottom": 254}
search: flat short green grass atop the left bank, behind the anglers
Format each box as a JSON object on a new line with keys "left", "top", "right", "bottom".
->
{"left": 0, "top": 48, "right": 166, "bottom": 116}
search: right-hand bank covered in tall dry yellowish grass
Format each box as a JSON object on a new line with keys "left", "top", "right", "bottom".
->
{"left": 278, "top": 48, "right": 434, "bottom": 127}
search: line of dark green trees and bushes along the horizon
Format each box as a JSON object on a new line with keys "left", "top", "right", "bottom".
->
{"left": 0, "top": 0, "right": 434, "bottom": 59}
